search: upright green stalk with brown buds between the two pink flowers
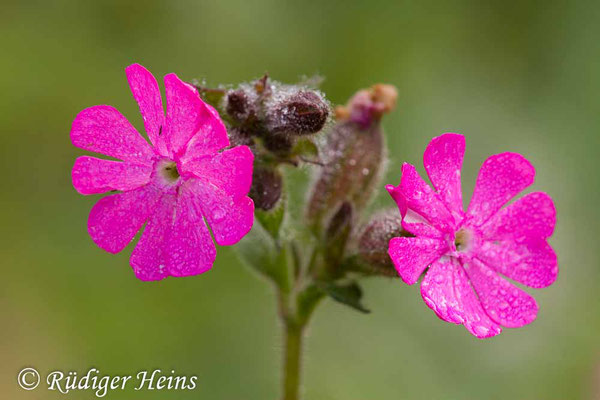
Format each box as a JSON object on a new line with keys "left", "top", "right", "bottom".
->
{"left": 206, "top": 76, "right": 400, "bottom": 400}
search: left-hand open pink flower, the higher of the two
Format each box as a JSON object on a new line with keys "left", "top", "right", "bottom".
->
{"left": 71, "top": 64, "right": 254, "bottom": 281}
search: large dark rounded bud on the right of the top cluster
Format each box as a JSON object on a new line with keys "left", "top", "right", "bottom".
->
{"left": 265, "top": 87, "right": 329, "bottom": 135}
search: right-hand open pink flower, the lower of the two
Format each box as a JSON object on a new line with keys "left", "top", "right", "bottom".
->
{"left": 386, "top": 133, "right": 558, "bottom": 338}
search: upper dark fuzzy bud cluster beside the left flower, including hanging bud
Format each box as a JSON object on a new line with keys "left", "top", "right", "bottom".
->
{"left": 199, "top": 75, "right": 330, "bottom": 210}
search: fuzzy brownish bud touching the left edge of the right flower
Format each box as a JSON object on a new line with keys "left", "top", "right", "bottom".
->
{"left": 358, "top": 208, "right": 412, "bottom": 275}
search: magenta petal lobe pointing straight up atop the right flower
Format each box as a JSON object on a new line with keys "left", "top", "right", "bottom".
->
{"left": 423, "top": 133, "right": 465, "bottom": 220}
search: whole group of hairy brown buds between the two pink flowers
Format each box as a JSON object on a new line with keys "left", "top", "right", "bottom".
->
{"left": 198, "top": 76, "right": 406, "bottom": 282}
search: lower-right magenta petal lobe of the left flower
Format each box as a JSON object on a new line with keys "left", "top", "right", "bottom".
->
{"left": 186, "top": 179, "right": 254, "bottom": 246}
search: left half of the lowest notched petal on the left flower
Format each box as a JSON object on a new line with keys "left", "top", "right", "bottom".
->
{"left": 129, "top": 192, "right": 177, "bottom": 281}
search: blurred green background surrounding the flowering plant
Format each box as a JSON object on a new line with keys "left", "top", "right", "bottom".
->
{"left": 0, "top": 0, "right": 600, "bottom": 400}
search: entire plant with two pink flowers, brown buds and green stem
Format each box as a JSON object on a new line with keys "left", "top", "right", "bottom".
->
{"left": 71, "top": 64, "right": 558, "bottom": 400}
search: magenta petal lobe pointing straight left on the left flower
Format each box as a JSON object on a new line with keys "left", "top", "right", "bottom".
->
{"left": 71, "top": 156, "right": 152, "bottom": 194}
